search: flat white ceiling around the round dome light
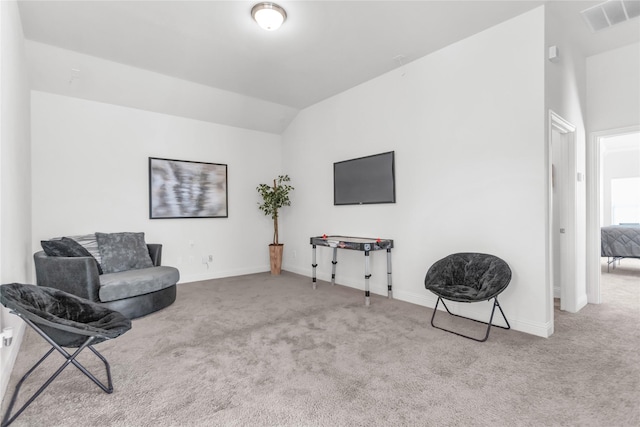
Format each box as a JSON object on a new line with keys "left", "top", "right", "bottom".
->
{"left": 19, "top": 0, "right": 640, "bottom": 132}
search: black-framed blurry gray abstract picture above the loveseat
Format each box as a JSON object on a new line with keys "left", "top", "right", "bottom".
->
{"left": 149, "top": 157, "right": 229, "bottom": 219}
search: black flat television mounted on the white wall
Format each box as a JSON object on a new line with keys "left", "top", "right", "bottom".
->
{"left": 333, "top": 151, "right": 396, "bottom": 205}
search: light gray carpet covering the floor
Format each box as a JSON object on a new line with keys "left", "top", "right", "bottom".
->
{"left": 3, "top": 260, "right": 640, "bottom": 426}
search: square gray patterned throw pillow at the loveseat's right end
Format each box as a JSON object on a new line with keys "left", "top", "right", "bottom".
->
{"left": 96, "top": 233, "right": 153, "bottom": 274}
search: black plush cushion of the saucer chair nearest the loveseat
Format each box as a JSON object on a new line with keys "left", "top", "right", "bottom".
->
{"left": 0, "top": 283, "right": 131, "bottom": 347}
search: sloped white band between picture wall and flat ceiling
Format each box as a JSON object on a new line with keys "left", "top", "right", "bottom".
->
{"left": 26, "top": 41, "right": 298, "bottom": 134}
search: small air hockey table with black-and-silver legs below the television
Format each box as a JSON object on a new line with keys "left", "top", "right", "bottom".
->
{"left": 309, "top": 234, "right": 393, "bottom": 306}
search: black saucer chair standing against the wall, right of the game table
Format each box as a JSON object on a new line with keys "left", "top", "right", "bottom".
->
{"left": 424, "top": 253, "right": 511, "bottom": 342}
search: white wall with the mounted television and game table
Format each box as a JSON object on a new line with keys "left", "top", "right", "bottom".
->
{"left": 281, "top": 8, "right": 552, "bottom": 336}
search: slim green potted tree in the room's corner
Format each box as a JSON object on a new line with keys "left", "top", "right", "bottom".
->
{"left": 256, "top": 175, "right": 294, "bottom": 275}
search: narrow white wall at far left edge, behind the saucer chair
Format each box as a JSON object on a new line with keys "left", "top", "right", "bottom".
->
{"left": 0, "top": 1, "right": 31, "bottom": 401}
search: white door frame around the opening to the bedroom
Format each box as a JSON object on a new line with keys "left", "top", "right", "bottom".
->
{"left": 586, "top": 125, "right": 640, "bottom": 304}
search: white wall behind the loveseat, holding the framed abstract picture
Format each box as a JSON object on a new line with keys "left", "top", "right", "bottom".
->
{"left": 31, "top": 87, "right": 281, "bottom": 282}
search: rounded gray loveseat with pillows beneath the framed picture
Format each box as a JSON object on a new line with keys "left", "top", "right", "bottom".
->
{"left": 33, "top": 233, "right": 180, "bottom": 319}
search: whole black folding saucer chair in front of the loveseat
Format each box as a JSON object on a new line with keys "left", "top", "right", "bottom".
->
{"left": 0, "top": 283, "right": 131, "bottom": 427}
